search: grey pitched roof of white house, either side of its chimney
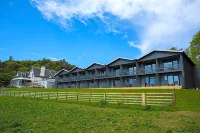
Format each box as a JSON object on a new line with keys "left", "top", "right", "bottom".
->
{"left": 32, "top": 67, "right": 56, "bottom": 78}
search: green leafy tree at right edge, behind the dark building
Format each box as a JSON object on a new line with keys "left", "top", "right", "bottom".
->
{"left": 185, "top": 31, "right": 200, "bottom": 66}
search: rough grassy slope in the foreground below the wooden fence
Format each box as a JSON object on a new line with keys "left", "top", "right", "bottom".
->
{"left": 0, "top": 97, "right": 200, "bottom": 133}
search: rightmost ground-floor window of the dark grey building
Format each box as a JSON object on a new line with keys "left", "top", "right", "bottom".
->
{"left": 164, "top": 75, "right": 180, "bottom": 86}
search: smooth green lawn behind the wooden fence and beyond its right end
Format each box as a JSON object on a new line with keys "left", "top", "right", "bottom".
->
{"left": 0, "top": 88, "right": 200, "bottom": 111}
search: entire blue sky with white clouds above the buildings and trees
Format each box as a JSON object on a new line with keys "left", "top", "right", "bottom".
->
{"left": 0, "top": 0, "right": 200, "bottom": 68}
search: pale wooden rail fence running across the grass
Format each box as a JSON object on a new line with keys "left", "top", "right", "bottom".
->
{"left": 0, "top": 91, "right": 176, "bottom": 106}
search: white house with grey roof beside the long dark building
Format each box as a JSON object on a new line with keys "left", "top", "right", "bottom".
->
{"left": 11, "top": 67, "right": 56, "bottom": 88}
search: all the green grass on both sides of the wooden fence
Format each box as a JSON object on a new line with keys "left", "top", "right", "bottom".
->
{"left": 0, "top": 88, "right": 200, "bottom": 133}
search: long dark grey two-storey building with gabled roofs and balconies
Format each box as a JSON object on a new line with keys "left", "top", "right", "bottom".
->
{"left": 55, "top": 50, "right": 200, "bottom": 88}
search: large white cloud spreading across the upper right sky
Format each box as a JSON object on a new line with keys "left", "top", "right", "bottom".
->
{"left": 31, "top": 0, "right": 200, "bottom": 53}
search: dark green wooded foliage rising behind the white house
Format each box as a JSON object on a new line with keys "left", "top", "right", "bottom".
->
{"left": 0, "top": 56, "right": 75, "bottom": 87}
